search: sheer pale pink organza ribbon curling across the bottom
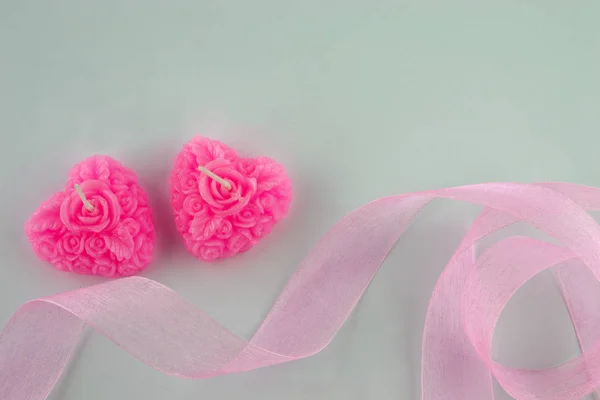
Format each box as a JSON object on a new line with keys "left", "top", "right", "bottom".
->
{"left": 0, "top": 183, "right": 600, "bottom": 400}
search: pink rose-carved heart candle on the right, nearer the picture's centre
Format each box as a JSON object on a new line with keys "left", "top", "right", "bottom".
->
{"left": 169, "top": 136, "right": 292, "bottom": 261}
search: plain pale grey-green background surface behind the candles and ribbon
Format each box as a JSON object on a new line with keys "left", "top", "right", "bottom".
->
{"left": 0, "top": 0, "right": 600, "bottom": 400}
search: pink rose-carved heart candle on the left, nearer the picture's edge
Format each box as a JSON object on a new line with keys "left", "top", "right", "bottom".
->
{"left": 25, "top": 155, "right": 156, "bottom": 277}
